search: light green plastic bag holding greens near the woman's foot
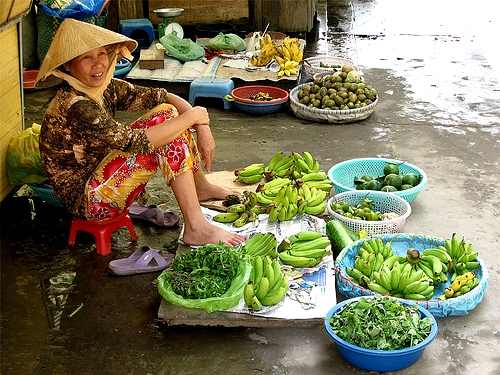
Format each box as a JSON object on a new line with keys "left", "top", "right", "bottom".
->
{"left": 158, "top": 258, "right": 252, "bottom": 314}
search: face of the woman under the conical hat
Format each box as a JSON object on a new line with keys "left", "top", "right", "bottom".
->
{"left": 64, "top": 47, "right": 109, "bottom": 87}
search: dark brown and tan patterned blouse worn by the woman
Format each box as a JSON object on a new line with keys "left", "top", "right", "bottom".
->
{"left": 39, "top": 79, "right": 168, "bottom": 217}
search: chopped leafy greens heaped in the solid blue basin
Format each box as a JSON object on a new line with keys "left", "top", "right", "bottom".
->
{"left": 326, "top": 296, "right": 433, "bottom": 350}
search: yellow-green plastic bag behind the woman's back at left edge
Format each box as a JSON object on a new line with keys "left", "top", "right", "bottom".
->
{"left": 7, "top": 124, "right": 47, "bottom": 185}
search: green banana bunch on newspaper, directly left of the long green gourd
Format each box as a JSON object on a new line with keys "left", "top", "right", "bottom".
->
{"left": 278, "top": 231, "right": 330, "bottom": 268}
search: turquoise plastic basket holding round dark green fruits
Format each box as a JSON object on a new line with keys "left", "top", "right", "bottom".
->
{"left": 328, "top": 158, "right": 428, "bottom": 203}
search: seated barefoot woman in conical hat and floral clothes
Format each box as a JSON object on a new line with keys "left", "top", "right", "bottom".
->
{"left": 35, "top": 19, "right": 244, "bottom": 246}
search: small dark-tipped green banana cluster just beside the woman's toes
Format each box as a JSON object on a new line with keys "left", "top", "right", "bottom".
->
{"left": 213, "top": 190, "right": 262, "bottom": 228}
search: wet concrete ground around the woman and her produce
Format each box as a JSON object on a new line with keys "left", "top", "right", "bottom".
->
{"left": 0, "top": 0, "right": 500, "bottom": 375}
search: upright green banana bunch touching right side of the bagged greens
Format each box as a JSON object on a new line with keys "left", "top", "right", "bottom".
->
{"left": 243, "top": 256, "right": 289, "bottom": 311}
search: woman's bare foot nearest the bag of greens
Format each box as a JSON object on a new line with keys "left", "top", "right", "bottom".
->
{"left": 182, "top": 221, "right": 246, "bottom": 246}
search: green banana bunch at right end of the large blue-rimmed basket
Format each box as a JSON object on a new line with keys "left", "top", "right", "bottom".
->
{"left": 438, "top": 233, "right": 479, "bottom": 281}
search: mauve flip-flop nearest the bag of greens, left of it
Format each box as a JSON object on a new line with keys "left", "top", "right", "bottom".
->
{"left": 108, "top": 246, "right": 175, "bottom": 276}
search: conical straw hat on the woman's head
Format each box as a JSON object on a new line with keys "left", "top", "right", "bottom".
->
{"left": 35, "top": 18, "right": 137, "bottom": 86}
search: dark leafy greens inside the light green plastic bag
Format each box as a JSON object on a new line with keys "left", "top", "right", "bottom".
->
{"left": 165, "top": 243, "right": 243, "bottom": 299}
